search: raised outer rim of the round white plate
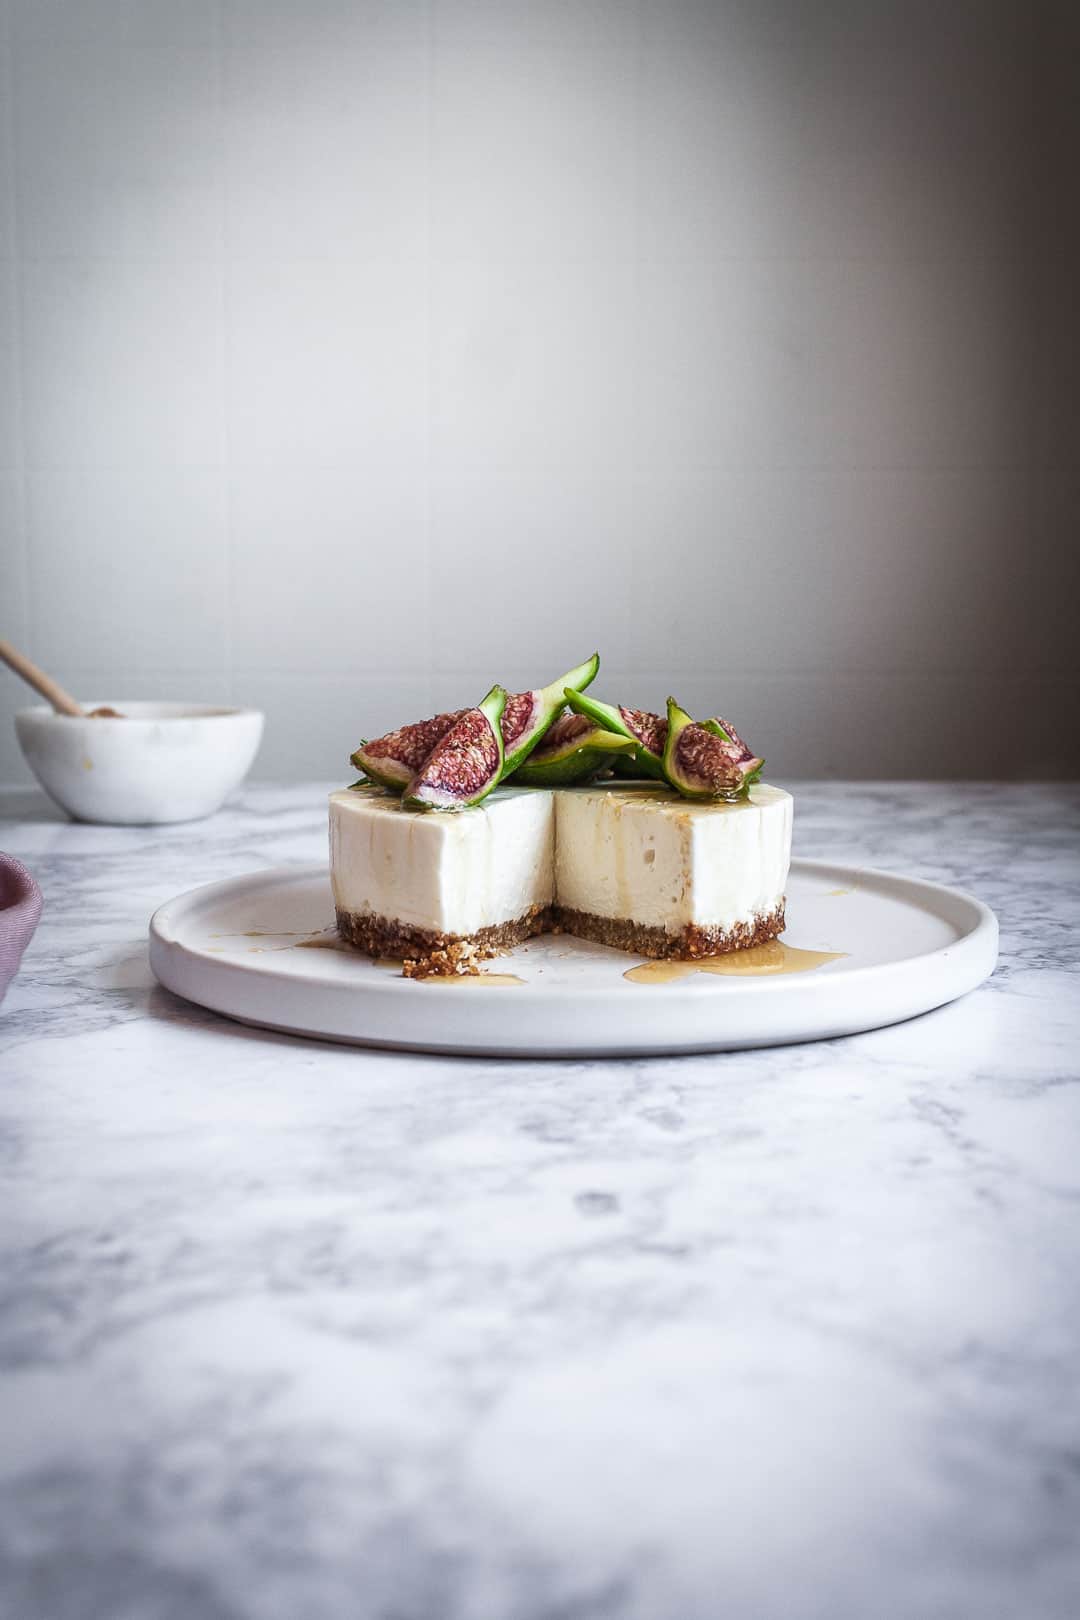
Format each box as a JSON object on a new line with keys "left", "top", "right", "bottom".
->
{"left": 149, "top": 857, "right": 999, "bottom": 1061}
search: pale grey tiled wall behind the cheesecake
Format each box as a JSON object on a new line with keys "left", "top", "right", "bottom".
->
{"left": 0, "top": 0, "right": 1080, "bottom": 781}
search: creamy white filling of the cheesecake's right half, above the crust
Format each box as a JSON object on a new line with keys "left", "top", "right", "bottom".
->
{"left": 555, "top": 784, "right": 792, "bottom": 935}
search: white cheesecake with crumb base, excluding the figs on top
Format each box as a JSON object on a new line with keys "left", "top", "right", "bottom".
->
{"left": 330, "top": 782, "right": 792, "bottom": 972}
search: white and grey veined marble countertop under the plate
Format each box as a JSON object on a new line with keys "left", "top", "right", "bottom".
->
{"left": 0, "top": 784, "right": 1080, "bottom": 1620}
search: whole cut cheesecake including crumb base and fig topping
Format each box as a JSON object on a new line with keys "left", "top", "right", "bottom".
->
{"left": 330, "top": 658, "right": 793, "bottom": 977}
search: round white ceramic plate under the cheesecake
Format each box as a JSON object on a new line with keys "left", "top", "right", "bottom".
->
{"left": 151, "top": 860, "right": 997, "bottom": 1058}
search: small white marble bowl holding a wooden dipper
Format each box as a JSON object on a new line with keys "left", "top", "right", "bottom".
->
{"left": 15, "top": 698, "right": 262, "bottom": 826}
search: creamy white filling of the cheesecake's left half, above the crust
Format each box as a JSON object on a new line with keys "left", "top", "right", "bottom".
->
{"left": 330, "top": 787, "right": 555, "bottom": 935}
